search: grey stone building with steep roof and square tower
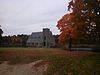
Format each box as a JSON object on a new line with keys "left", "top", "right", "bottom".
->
{"left": 27, "top": 28, "right": 55, "bottom": 47}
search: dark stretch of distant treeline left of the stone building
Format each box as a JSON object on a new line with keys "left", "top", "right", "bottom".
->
{"left": 0, "top": 34, "right": 29, "bottom": 47}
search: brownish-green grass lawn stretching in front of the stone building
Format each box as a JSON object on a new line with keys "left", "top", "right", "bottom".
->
{"left": 0, "top": 48, "right": 100, "bottom": 75}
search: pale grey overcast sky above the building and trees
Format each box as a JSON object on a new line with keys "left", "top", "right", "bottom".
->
{"left": 0, "top": 0, "right": 69, "bottom": 35}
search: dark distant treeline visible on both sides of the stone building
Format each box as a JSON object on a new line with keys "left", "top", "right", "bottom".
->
{"left": 0, "top": 34, "right": 100, "bottom": 47}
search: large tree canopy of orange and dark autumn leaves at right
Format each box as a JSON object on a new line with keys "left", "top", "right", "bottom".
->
{"left": 57, "top": 0, "right": 100, "bottom": 44}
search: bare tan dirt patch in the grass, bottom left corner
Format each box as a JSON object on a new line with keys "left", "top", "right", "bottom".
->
{"left": 0, "top": 60, "right": 48, "bottom": 75}
